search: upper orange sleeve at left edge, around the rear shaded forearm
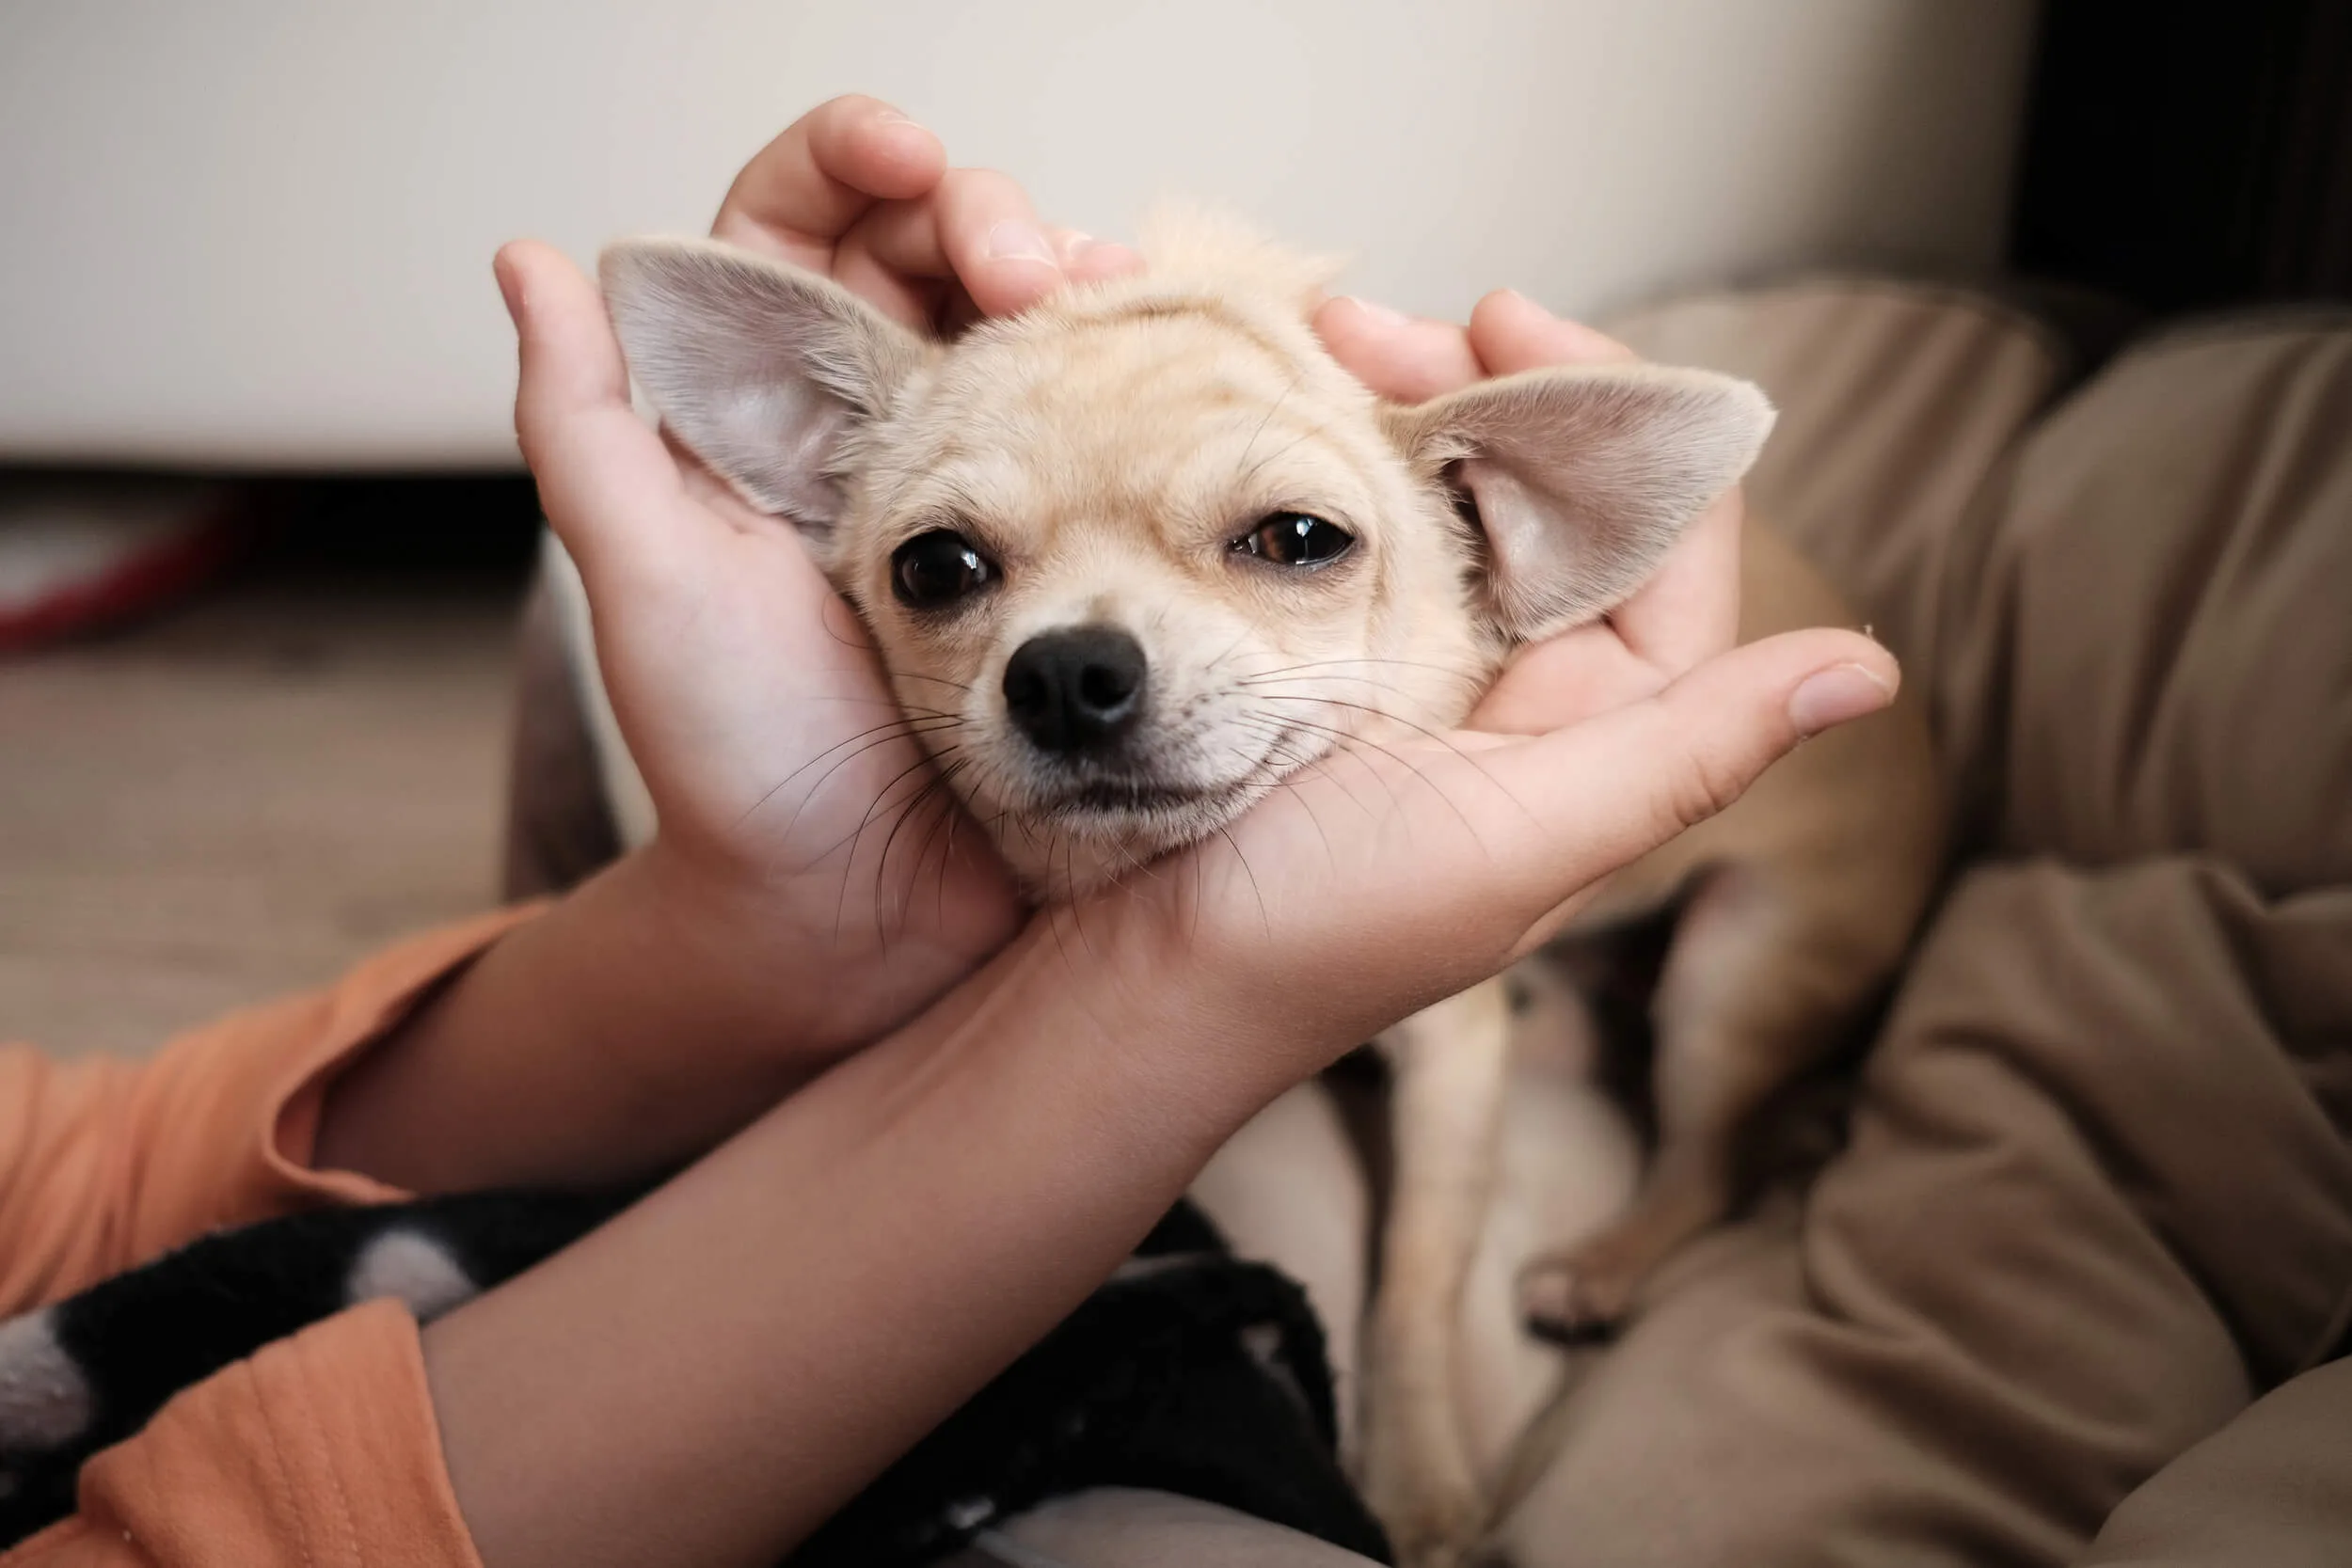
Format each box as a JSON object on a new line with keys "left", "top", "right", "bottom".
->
{"left": 0, "top": 910, "right": 534, "bottom": 1317}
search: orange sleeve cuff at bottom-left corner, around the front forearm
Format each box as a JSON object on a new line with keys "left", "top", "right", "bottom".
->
{"left": 0, "top": 1303, "right": 483, "bottom": 1568}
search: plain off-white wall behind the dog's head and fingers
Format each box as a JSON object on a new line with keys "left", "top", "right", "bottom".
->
{"left": 0, "top": 0, "right": 2032, "bottom": 466}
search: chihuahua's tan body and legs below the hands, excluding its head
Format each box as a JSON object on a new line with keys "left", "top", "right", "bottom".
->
{"left": 1359, "top": 527, "right": 1946, "bottom": 1563}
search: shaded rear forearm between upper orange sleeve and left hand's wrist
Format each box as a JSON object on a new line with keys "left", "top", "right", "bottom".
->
{"left": 313, "top": 851, "right": 889, "bottom": 1192}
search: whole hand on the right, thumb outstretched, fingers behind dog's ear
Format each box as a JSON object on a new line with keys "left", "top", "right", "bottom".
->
{"left": 1054, "top": 293, "right": 1899, "bottom": 1109}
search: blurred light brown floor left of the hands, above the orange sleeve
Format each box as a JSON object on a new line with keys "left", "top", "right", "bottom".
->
{"left": 0, "top": 496, "right": 520, "bottom": 1051}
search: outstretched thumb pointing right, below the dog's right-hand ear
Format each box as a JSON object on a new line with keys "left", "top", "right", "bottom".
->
{"left": 1480, "top": 630, "right": 1900, "bottom": 940}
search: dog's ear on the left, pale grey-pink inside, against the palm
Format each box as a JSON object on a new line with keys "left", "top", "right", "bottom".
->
{"left": 597, "top": 240, "right": 931, "bottom": 536}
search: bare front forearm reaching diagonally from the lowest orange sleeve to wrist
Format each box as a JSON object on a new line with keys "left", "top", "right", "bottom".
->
{"left": 426, "top": 931, "right": 1278, "bottom": 1568}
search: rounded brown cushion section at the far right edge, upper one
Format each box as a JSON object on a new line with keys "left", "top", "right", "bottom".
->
{"left": 1941, "top": 317, "right": 2352, "bottom": 894}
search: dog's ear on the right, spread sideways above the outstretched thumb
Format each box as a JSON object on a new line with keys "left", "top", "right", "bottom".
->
{"left": 1388, "top": 364, "right": 1773, "bottom": 641}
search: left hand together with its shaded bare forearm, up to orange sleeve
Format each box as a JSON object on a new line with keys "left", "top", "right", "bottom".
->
{"left": 313, "top": 99, "right": 1141, "bottom": 1192}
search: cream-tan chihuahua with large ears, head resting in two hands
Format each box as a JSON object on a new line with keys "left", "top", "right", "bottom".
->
{"left": 583, "top": 214, "right": 1936, "bottom": 1566}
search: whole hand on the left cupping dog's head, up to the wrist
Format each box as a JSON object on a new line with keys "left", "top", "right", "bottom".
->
{"left": 497, "top": 96, "right": 1141, "bottom": 1049}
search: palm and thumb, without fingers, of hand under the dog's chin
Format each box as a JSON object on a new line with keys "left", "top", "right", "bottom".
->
{"left": 1073, "top": 630, "right": 1899, "bottom": 1112}
